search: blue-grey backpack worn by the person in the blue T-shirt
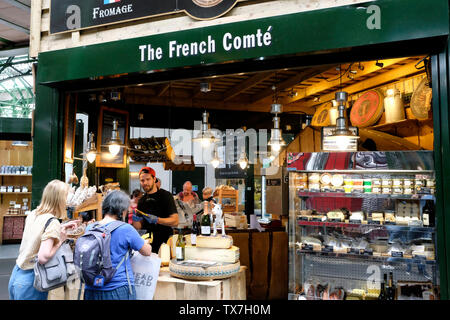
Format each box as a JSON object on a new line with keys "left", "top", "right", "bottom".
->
{"left": 73, "top": 221, "right": 131, "bottom": 292}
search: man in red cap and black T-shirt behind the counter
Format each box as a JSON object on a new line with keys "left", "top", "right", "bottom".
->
{"left": 133, "top": 167, "right": 178, "bottom": 253}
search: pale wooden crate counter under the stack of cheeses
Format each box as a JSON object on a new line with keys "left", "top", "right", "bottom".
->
{"left": 153, "top": 266, "right": 247, "bottom": 300}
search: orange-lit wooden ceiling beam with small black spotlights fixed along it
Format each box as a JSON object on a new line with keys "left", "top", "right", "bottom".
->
{"left": 280, "top": 58, "right": 408, "bottom": 105}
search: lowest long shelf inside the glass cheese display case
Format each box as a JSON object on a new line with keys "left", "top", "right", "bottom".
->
{"left": 296, "top": 249, "right": 437, "bottom": 265}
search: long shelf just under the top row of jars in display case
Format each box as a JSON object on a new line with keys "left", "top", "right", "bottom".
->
{"left": 297, "top": 191, "right": 436, "bottom": 200}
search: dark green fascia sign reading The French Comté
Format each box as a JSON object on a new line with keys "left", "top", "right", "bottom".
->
{"left": 38, "top": 0, "right": 449, "bottom": 84}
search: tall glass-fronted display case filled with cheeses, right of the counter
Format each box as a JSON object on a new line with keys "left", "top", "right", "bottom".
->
{"left": 287, "top": 151, "right": 439, "bottom": 300}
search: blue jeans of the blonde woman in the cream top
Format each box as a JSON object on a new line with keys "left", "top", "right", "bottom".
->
{"left": 8, "top": 265, "right": 48, "bottom": 300}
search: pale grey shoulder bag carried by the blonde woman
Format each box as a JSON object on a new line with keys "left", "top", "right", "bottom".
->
{"left": 33, "top": 218, "right": 77, "bottom": 292}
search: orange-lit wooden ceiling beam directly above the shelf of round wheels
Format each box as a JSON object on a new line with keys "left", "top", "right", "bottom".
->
{"left": 301, "top": 61, "right": 425, "bottom": 108}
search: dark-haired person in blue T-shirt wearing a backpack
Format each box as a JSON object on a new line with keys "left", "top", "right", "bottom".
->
{"left": 80, "top": 190, "right": 152, "bottom": 300}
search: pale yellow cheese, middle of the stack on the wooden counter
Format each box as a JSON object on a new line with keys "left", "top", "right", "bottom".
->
{"left": 184, "top": 246, "right": 240, "bottom": 263}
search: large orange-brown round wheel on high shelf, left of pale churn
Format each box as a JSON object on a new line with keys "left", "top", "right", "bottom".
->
{"left": 350, "top": 90, "right": 384, "bottom": 128}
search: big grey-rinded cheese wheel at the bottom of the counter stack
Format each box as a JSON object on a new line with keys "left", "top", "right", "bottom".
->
{"left": 169, "top": 259, "right": 241, "bottom": 280}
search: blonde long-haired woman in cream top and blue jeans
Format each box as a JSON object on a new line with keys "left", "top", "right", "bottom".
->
{"left": 8, "top": 180, "right": 77, "bottom": 300}
